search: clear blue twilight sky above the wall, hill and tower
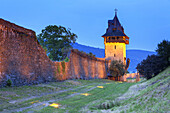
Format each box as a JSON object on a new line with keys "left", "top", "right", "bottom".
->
{"left": 0, "top": 0, "right": 170, "bottom": 51}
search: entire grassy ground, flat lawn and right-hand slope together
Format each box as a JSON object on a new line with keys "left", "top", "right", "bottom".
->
{"left": 0, "top": 67, "right": 170, "bottom": 113}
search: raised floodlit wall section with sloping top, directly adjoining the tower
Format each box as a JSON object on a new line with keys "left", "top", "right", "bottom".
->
{"left": 67, "top": 50, "right": 108, "bottom": 79}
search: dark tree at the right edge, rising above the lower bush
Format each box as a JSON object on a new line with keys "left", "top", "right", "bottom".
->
{"left": 156, "top": 40, "right": 170, "bottom": 65}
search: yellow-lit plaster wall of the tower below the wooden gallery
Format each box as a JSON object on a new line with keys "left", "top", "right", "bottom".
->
{"left": 105, "top": 43, "right": 126, "bottom": 64}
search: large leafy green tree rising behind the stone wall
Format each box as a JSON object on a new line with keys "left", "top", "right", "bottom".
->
{"left": 37, "top": 25, "right": 77, "bottom": 61}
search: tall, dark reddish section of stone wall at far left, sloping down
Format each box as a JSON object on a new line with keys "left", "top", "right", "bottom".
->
{"left": 0, "top": 19, "right": 54, "bottom": 86}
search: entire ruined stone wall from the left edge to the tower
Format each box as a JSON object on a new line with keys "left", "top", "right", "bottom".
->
{"left": 0, "top": 19, "right": 107, "bottom": 87}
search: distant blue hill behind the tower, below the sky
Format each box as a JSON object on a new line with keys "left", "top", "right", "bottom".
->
{"left": 73, "top": 43, "right": 156, "bottom": 72}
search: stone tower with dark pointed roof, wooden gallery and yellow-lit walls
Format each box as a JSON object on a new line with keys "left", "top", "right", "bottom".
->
{"left": 102, "top": 9, "right": 129, "bottom": 64}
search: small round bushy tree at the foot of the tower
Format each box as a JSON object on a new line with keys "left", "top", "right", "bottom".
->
{"left": 109, "top": 60, "right": 126, "bottom": 78}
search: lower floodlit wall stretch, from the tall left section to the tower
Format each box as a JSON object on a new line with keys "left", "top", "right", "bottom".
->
{"left": 54, "top": 50, "right": 108, "bottom": 80}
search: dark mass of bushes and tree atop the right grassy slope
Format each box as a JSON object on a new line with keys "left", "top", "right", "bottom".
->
{"left": 136, "top": 40, "right": 170, "bottom": 79}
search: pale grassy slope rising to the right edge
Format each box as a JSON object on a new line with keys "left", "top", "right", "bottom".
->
{"left": 102, "top": 67, "right": 170, "bottom": 113}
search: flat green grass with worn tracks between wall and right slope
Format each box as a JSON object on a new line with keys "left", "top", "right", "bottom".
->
{"left": 0, "top": 79, "right": 135, "bottom": 113}
